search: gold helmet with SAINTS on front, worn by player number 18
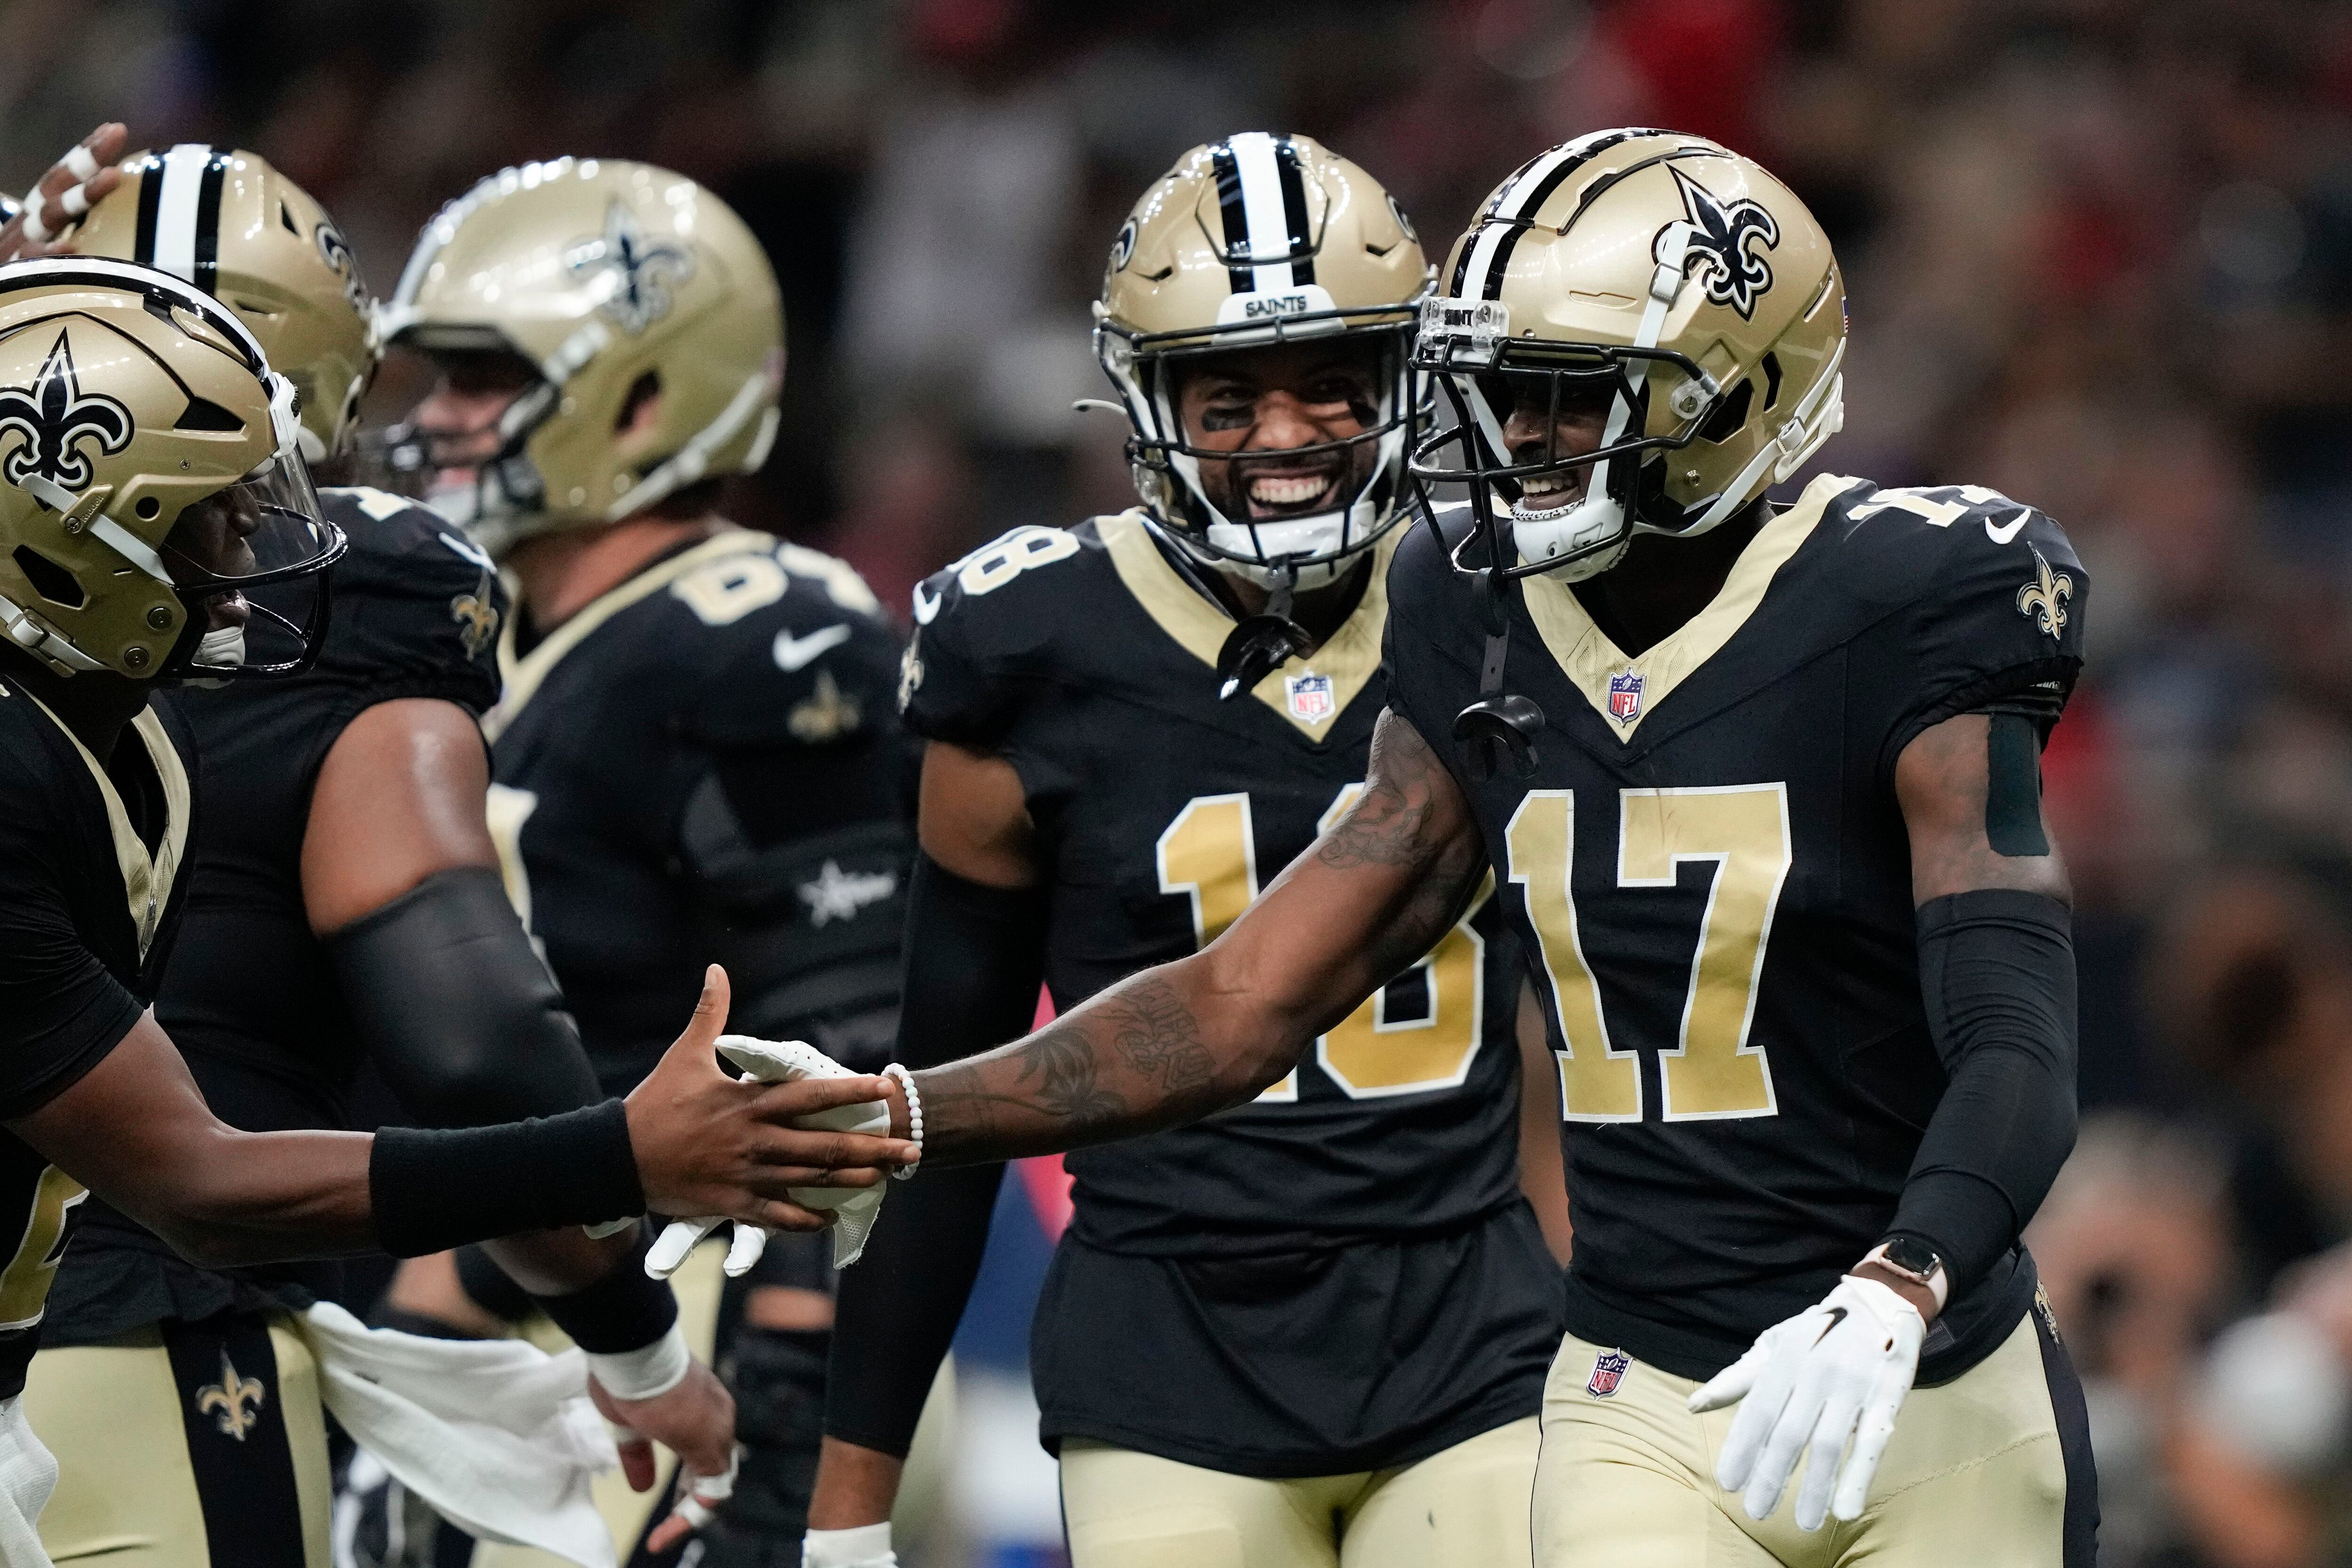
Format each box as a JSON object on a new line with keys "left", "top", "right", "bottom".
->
{"left": 1094, "top": 132, "right": 1432, "bottom": 588}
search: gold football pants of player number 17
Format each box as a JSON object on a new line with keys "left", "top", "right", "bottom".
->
{"left": 1534, "top": 1312, "right": 2098, "bottom": 1568}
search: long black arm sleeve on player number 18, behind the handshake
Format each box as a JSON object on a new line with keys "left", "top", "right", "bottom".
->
{"left": 826, "top": 853, "right": 1047, "bottom": 1455}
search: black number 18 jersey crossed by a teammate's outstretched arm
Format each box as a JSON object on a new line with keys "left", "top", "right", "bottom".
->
{"left": 903, "top": 512, "right": 1519, "bottom": 1255}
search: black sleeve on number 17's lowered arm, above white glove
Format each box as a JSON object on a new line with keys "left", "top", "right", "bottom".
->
{"left": 1886, "top": 889, "right": 2074, "bottom": 1295}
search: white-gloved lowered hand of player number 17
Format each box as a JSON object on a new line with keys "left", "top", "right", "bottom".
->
{"left": 1691, "top": 1274, "right": 1926, "bottom": 1530}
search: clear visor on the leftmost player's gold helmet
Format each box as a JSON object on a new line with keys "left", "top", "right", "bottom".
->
{"left": 160, "top": 451, "right": 346, "bottom": 679}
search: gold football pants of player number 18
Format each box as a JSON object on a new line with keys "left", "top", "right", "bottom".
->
{"left": 1061, "top": 1415, "right": 1536, "bottom": 1568}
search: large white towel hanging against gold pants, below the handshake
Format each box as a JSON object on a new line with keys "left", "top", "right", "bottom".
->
{"left": 294, "top": 1302, "right": 621, "bottom": 1568}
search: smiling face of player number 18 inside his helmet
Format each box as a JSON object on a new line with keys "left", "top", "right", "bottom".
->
{"left": 1176, "top": 341, "right": 1381, "bottom": 522}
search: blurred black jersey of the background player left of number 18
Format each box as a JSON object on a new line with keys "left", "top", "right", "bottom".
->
{"left": 485, "top": 529, "right": 913, "bottom": 1093}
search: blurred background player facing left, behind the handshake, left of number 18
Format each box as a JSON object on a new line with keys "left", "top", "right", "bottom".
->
{"left": 383, "top": 158, "right": 910, "bottom": 1563}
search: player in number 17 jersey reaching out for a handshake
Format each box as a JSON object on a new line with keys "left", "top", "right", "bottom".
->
{"left": 847, "top": 129, "right": 2098, "bottom": 1568}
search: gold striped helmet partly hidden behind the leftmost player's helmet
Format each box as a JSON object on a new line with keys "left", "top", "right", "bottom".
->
{"left": 68, "top": 143, "right": 381, "bottom": 463}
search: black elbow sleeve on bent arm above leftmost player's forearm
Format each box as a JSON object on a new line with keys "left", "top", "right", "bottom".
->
{"left": 327, "top": 865, "right": 604, "bottom": 1126}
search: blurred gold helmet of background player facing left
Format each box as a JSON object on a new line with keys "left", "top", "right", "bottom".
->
{"left": 381, "top": 158, "right": 783, "bottom": 555}
